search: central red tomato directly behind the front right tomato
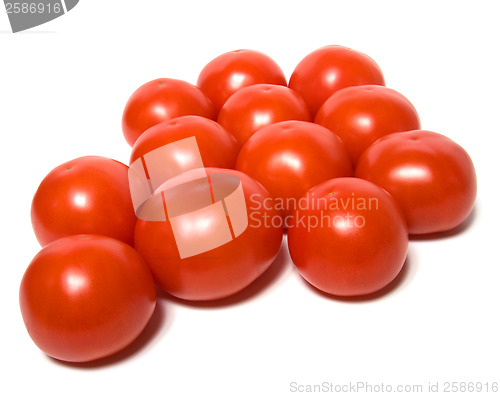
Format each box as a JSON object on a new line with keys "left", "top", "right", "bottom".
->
{"left": 236, "top": 121, "right": 353, "bottom": 221}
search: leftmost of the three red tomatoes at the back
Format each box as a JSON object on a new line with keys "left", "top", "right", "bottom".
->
{"left": 122, "top": 78, "right": 217, "bottom": 146}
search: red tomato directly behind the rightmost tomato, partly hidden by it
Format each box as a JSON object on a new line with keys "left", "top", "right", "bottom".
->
{"left": 314, "top": 85, "right": 420, "bottom": 165}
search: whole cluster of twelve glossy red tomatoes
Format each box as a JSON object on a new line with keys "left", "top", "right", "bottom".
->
{"left": 20, "top": 46, "right": 476, "bottom": 362}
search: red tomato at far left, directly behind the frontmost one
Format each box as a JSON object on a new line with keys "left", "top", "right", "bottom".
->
{"left": 31, "top": 156, "right": 137, "bottom": 246}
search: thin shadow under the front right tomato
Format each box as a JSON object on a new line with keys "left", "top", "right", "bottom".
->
{"left": 302, "top": 253, "right": 415, "bottom": 303}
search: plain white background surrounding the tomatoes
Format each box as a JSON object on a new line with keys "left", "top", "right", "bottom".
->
{"left": 0, "top": 0, "right": 500, "bottom": 396}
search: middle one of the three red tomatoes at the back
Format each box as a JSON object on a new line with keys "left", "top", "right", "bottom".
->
{"left": 197, "top": 49, "right": 286, "bottom": 111}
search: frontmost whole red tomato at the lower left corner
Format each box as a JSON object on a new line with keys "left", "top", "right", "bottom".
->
{"left": 19, "top": 235, "right": 156, "bottom": 362}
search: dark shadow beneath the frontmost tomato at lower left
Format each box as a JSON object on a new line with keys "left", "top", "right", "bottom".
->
{"left": 47, "top": 292, "right": 172, "bottom": 369}
